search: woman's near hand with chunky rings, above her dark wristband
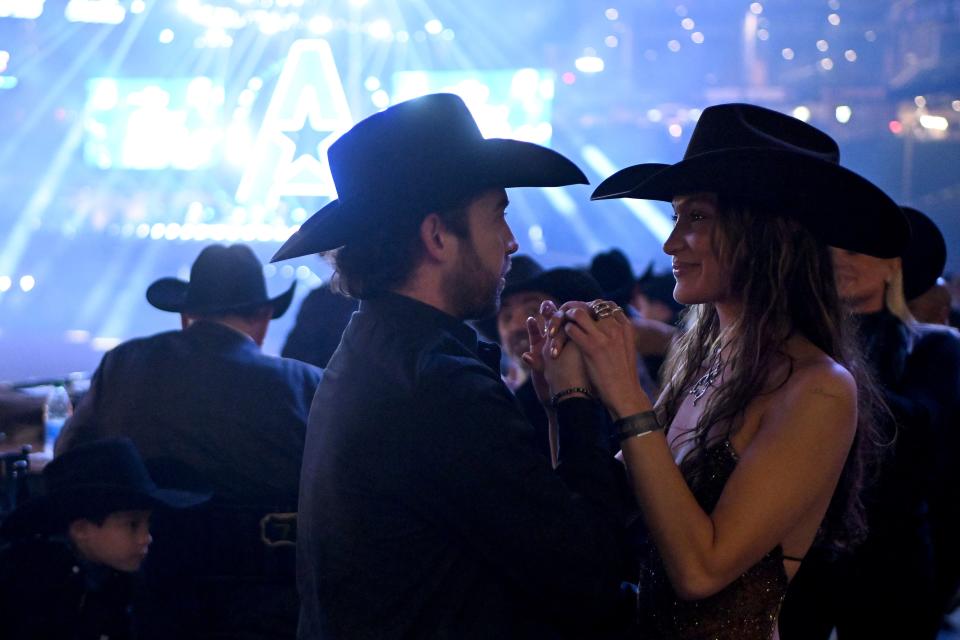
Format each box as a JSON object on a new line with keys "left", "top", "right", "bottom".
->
{"left": 564, "top": 300, "right": 652, "bottom": 419}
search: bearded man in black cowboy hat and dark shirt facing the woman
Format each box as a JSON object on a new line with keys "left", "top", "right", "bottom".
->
{"left": 274, "top": 94, "right": 626, "bottom": 638}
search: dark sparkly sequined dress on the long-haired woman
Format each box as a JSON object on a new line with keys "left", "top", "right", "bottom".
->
{"left": 637, "top": 440, "right": 787, "bottom": 640}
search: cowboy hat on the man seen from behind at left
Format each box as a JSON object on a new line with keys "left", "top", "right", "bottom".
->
{"left": 147, "top": 244, "right": 297, "bottom": 318}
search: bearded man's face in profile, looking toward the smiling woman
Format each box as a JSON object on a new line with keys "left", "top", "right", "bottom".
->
{"left": 443, "top": 189, "right": 518, "bottom": 320}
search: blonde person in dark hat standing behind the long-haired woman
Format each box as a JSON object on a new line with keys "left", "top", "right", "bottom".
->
{"left": 780, "top": 207, "right": 960, "bottom": 640}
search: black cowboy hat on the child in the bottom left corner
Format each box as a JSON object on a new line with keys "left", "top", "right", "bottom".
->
{"left": 0, "top": 438, "right": 210, "bottom": 537}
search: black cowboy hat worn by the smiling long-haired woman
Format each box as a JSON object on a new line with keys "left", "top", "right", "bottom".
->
{"left": 592, "top": 104, "right": 909, "bottom": 258}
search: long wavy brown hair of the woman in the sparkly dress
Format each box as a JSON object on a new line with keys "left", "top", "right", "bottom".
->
{"left": 657, "top": 199, "right": 879, "bottom": 548}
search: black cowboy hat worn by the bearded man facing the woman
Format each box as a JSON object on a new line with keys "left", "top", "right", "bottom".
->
{"left": 271, "top": 93, "right": 589, "bottom": 262}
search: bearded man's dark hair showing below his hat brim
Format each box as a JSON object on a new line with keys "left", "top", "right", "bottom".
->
{"left": 324, "top": 194, "right": 476, "bottom": 300}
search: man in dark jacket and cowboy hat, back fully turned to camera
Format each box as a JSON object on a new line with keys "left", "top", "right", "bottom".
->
{"left": 56, "top": 245, "right": 321, "bottom": 637}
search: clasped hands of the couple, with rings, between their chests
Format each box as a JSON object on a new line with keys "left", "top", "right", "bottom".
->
{"left": 523, "top": 300, "right": 650, "bottom": 417}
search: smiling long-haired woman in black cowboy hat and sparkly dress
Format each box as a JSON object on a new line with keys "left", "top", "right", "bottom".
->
{"left": 529, "top": 104, "right": 908, "bottom": 640}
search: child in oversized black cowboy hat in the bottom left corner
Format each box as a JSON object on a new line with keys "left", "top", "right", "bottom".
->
{"left": 0, "top": 439, "right": 210, "bottom": 640}
